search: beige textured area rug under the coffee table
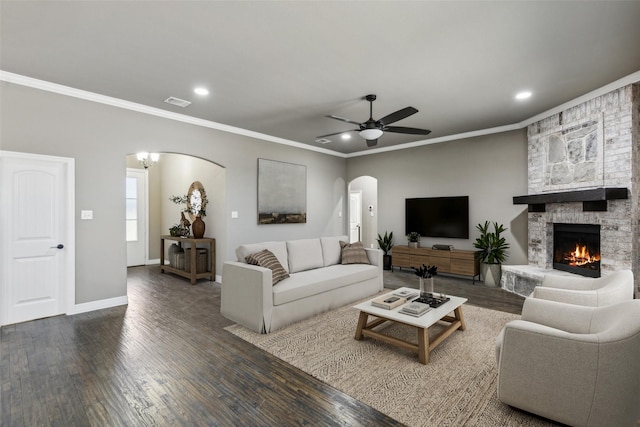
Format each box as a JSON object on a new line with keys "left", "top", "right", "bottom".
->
{"left": 225, "top": 298, "right": 555, "bottom": 426}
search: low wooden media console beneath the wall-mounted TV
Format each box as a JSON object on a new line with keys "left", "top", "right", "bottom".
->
{"left": 391, "top": 245, "right": 480, "bottom": 283}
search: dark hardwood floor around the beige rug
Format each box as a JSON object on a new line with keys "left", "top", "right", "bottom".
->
{"left": 0, "top": 266, "right": 522, "bottom": 426}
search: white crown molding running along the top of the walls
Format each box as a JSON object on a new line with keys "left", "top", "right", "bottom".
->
{"left": 0, "top": 70, "right": 640, "bottom": 159}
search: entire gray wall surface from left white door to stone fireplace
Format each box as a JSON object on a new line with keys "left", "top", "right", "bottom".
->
{"left": 0, "top": 82, "right": 527, "bottom": 304}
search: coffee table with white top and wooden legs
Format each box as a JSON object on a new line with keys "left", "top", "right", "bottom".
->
{"left": 353, "top": 288, "right": 467, "bottom": 365}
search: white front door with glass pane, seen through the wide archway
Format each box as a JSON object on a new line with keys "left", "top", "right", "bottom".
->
{"left": 126, "top": 168, "right": 148, "bottom": 267}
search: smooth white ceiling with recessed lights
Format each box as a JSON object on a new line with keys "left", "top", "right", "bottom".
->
{"left": 0, "top": 0, "right": 640, "bottom": 153}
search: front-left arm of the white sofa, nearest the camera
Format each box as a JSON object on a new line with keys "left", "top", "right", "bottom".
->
{"left": 220, "top": 261, "right": 273, "bottom": 334}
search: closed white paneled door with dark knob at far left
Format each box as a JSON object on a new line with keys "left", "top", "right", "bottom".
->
{"left": 0, "top": 151, "right": 75, "bottom": 324}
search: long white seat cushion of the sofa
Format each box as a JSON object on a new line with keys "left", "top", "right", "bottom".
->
{"left": 273, "top": 264, "right": 378, "bottom": 306}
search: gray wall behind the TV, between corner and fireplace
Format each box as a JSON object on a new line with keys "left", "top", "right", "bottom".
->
{"left": 347, "top": 129, "right": 527, "bottom": 264}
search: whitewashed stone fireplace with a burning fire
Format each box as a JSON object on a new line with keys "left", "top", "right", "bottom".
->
{"left": 501, "top": 84, "right": 640, "bottom": 296}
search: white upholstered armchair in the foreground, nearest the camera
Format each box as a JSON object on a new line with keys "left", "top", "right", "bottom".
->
{"left": 496, "top": 298, "right": 640, "bottom": 426}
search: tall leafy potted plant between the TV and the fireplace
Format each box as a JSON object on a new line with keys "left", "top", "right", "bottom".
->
{"left": 473, "top": 221, "right": 509, "bottom": 286}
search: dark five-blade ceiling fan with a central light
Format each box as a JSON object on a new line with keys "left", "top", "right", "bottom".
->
{"left": 316, "top": 95, "right": 431, "bottom": 147}
